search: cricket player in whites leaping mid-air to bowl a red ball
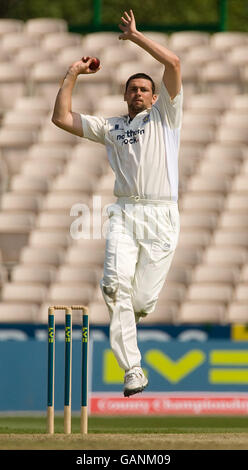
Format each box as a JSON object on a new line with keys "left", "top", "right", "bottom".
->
{"left": 52, "top": 10, "right": 183, "bottom": 396}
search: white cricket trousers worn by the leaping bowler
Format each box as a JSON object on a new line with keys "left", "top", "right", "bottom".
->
{"left": 100, "top": 198, "right": 180, "bottom": 371}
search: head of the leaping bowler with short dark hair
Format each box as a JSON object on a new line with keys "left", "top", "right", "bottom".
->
{"left": 124, "top": 78, "right": 157, "bottom": 118}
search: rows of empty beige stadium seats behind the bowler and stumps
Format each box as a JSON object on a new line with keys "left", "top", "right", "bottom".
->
{"left": 0, "top": 18, "right": 248, "bottom": 324}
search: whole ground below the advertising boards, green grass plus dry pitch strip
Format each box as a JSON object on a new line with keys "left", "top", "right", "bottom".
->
{"left": 0, "top": 416, "right": 248, "bottom": 450}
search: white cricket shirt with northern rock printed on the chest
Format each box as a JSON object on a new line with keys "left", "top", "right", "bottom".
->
{"left": 81, "top": 82, "right": 183, "bottom": 201}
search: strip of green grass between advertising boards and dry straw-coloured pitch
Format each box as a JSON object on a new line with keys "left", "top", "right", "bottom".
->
{"left": 0, "top": 416, "right": 248, "bottom": 434}
